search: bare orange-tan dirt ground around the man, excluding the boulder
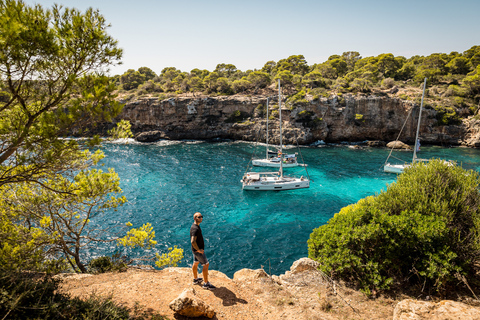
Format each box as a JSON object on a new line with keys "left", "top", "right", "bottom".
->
{"left": 57, "top": 268, "right": 402, "bottom": 320}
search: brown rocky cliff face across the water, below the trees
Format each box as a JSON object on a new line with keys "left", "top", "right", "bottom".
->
{"left": 115, "top": 95, "right": 480, "bottom": 147}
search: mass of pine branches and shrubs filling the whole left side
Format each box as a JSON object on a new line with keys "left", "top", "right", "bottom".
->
{"left": 0, "top": 0, "right": 183, "bottom": 319}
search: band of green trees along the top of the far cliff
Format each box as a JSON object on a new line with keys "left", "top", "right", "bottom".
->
{"left": 115, "top": 46, "right": 480, "bottom": 125}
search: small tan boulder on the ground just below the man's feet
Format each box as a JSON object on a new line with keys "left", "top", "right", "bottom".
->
{"left": 168, "top": 288, "right": 215, "bottom": 318}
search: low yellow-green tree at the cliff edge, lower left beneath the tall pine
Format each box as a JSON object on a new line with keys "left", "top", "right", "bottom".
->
{"left": 0, "top": 151, "right": 126, "bottom": 272}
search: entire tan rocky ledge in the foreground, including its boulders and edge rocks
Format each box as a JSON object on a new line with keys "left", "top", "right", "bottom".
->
{"left": 60, "top": 258, "right": 480, "bottom": 320}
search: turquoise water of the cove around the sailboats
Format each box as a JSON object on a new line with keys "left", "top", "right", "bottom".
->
{"left": 95, "top": 142, "right": 480, "bottom": 277}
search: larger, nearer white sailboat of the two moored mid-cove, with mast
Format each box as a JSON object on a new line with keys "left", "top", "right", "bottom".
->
{"left": 241, "top": 80, "right": 310, "bottom": 191}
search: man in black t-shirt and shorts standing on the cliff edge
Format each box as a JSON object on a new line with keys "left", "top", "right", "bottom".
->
{"left": 190, "top": 212, "right": 216, "bottom": 289}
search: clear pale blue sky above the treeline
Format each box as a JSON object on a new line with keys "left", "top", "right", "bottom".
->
{"left": 25, "top": 0, "right": 480, "bottom": 75}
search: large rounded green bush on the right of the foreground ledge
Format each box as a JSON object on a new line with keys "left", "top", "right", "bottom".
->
{"left": 308, "top": 160, "right": 480, "bottom": 294}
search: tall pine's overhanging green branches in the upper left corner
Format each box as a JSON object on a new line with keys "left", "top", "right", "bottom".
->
{"left": 0, "top": 1, "right": 122, "bottom": 186}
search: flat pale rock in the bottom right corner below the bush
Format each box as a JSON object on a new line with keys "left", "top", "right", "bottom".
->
{"left": 393, "top": 299, "right": 480, "bottom": 320}
